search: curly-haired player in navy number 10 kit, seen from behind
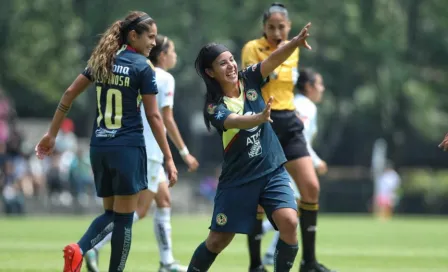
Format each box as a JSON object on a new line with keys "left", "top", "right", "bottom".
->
{"left": 36, "top": 12, "right": 177, "bottom": 272}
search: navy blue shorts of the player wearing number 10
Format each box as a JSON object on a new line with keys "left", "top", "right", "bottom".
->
{"left": 90, "top": 146, "right": 148, "bottom": 197}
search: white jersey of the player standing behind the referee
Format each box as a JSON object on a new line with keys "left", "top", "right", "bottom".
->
{"left": 294, "top": 94, "right": 322, "bottom": 167}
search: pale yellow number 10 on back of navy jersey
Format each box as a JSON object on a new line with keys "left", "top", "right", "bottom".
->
{"left": 96, "top": 86, "right": 123, "bottom": 129}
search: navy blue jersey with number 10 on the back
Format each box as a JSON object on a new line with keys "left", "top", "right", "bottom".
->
{"left": 83, "top": 45, "right": 157, "bottom": 146}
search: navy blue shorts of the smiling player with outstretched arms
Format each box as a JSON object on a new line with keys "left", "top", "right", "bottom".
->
{"left": 210, "top": 167, "right": 297, "bottom": 234}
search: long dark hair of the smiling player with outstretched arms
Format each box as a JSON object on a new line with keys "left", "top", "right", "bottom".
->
{"left": 194, "top": 43, "right": 233, "bottom": 131}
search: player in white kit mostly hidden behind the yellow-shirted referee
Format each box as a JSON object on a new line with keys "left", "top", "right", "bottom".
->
{"left": 263, "top": 69, "right": 328, "bottom": 265}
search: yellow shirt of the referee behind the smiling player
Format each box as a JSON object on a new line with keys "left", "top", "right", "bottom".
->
{"left": 241, "top": 37, "right": 299, "bottom": 110}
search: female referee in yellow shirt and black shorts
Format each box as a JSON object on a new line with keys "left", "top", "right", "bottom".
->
{"left": 242, "top": 3, "right": 336, "bottom": 272}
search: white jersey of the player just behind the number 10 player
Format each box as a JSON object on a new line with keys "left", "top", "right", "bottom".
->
{"left": 141, "top": 67, "right": 174, "bottom": 163}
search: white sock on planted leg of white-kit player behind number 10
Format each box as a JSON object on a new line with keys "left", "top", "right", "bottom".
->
{"left": 154, "top": 208, "right": 174, "bottom": 264}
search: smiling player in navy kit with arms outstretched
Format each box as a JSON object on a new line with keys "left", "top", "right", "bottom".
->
{"left": 188, "top": 21, "right": 311, "bottom": 272}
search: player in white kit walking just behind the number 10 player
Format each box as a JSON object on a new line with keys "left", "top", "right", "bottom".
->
{"left": 86, "top": 35, "right": 199, "bottom": 272}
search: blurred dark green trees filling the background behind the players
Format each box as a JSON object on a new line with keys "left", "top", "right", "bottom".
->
{"left": 0, "top": 0, "right": 448, "bottom": 163}
